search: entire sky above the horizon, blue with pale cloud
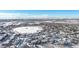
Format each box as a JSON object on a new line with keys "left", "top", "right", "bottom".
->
{"left": 0, "top": 10, "right": 79, "bottom": 19}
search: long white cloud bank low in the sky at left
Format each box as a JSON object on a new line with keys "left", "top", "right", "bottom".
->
{"left": 0, "top": 13, "right": 49, "bottom": 19}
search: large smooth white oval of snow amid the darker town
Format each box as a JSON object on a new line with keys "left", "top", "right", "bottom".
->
{"left": 13, "top": 26, "right": 42, "bottom": 34}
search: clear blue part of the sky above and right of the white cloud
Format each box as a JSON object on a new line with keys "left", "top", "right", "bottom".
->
{"left": 0, "top": 10, "right": 79, "bottom": 18}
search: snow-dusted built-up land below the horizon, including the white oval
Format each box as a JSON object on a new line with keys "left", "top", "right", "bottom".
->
{"left": 0, "top": 20, "right": 79, "bottom": 48}
